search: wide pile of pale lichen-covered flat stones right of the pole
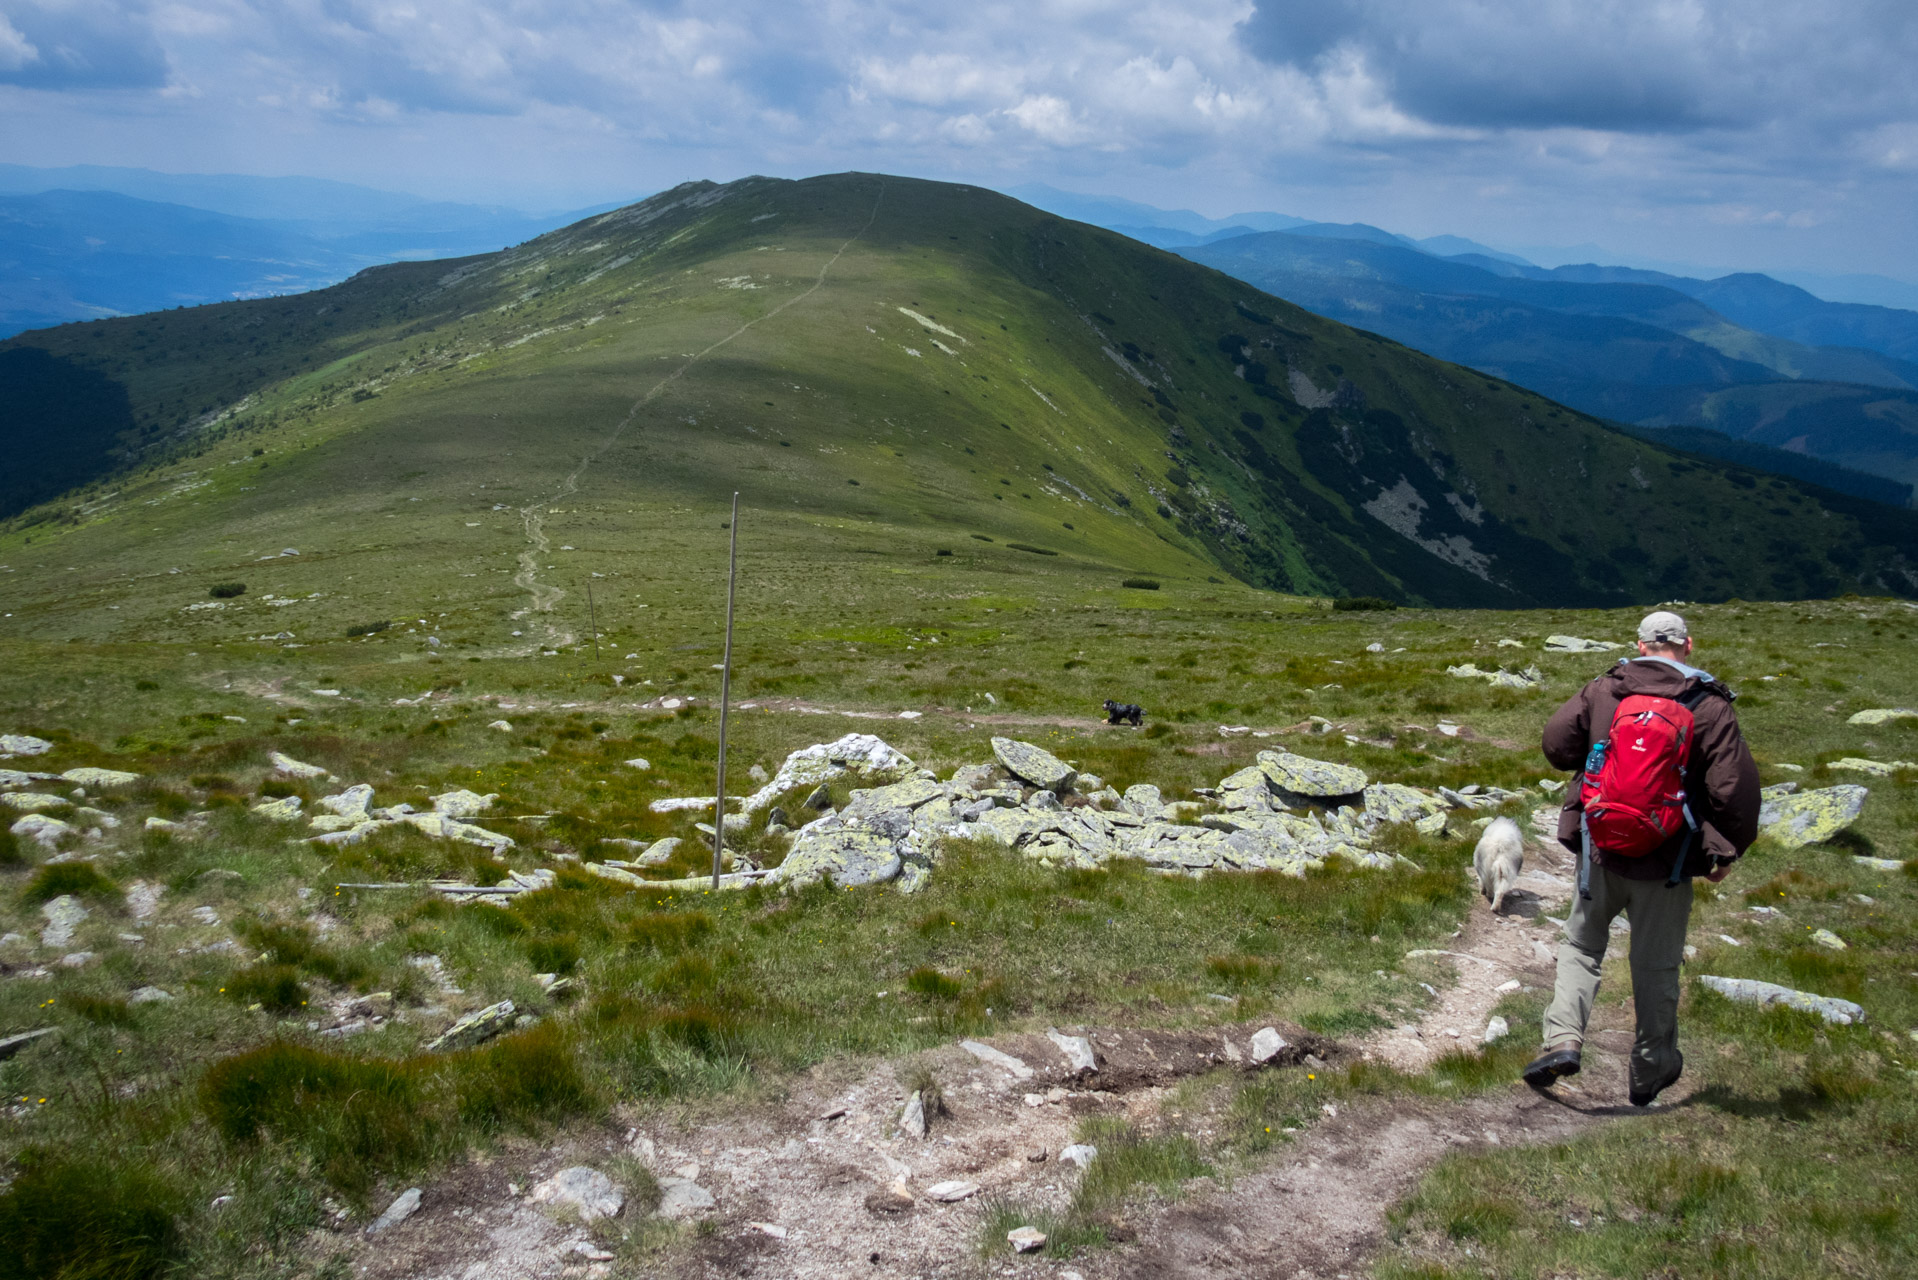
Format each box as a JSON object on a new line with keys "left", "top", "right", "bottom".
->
{"left": 746, "top": 735, "right": 1519, "bottom": 892}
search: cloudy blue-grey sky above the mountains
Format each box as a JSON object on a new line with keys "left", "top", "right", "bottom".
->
{"left": 0, "top": 0, "right": 1918, "bottom": 278}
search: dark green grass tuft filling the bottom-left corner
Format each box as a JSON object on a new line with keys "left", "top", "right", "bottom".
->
{"left": 0, "top": 1150, "right": 184, "bottom": 1280}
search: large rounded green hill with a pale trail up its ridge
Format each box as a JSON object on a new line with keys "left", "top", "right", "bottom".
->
{"left": 0, "top": 175, "right": 1918, "bottom": 629}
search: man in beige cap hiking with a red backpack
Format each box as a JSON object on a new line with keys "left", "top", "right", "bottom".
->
{"left": 1525, "top": 610, "right": 1759, "bottom": 1107}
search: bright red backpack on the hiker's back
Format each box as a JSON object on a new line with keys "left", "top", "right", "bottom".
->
{"left": 1579, "top": 687, "right": 1705, "bottom": 896}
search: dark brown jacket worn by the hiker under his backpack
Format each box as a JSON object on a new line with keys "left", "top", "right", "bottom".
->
{"left": 1542, "top": 658, "right": 1759, "bottom": 881}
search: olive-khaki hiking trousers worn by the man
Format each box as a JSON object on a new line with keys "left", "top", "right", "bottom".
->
{"left": 1544, "top": 867, "right": 1692, "bottom": 1092}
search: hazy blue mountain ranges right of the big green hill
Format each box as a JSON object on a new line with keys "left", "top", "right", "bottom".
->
{"left": 1013, "top": 186, "right": 1918, "bottom": 505}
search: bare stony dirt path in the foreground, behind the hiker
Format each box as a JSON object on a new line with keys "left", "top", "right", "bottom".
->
{"left": 313, "top": 817, "right": 1688, "bottom": 1280}
